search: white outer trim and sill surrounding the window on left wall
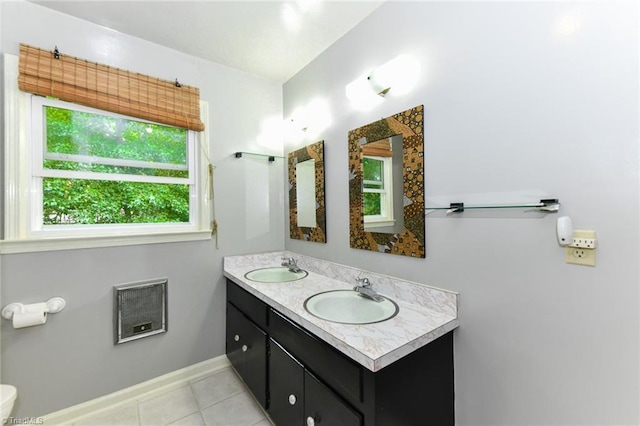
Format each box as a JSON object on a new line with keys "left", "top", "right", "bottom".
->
{"left": 0, "top": 54, "right": 213, "bottom": 254}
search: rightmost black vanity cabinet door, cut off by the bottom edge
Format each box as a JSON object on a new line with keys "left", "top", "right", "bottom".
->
{"left": 304, "top": 371, "right": 362, "bottom": 426}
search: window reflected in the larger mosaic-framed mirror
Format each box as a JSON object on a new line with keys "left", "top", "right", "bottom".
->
{"left": 362, "top": 155, "right": 393, "bottom": 228}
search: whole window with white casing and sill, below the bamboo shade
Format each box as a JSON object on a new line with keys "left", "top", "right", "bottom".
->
{"left": 2, "top": 54, "right": 211, "bottom": 252}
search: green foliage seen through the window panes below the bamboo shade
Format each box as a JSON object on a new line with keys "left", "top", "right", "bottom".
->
{"left": 43, "top": 107, "right": 189, "bottom": 225}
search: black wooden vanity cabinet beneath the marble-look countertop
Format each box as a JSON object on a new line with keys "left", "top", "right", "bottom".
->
{"left": 227, "top": 281, "right": 455, "bottom": 426}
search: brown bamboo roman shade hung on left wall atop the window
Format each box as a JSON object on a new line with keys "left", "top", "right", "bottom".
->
{"left": 18, "top": 44, "right": 204, "bottom": 131}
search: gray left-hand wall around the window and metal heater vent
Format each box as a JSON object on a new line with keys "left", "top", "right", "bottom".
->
{"left": 0, "top": 2, "right": 284, "bottom": 417}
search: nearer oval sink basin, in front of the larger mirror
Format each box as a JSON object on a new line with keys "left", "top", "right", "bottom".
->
{"left": 304, "top": 290, "right": 399, "bottom": 324}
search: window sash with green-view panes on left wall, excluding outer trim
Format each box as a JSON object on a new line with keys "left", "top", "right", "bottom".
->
{"left": 31, "top": 97, "right": 195, "bottom": 226}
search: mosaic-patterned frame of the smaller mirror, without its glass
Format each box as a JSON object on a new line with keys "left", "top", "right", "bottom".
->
{"left": 288, "top": 141, "right": 327, "bottom": 243}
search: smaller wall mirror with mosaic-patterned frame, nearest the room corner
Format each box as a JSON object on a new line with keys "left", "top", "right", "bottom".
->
{"left": 288, "top": 141, "right": 327, "bottom": 243}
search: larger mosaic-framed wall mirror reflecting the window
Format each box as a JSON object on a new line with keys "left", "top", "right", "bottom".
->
{"left": 349, "top": 105, "right": 426, "bottom": 258}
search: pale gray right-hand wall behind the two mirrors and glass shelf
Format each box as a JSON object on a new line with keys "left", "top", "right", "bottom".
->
{"left": 284, "top": 1, "right": 640, "bottom": 425}
